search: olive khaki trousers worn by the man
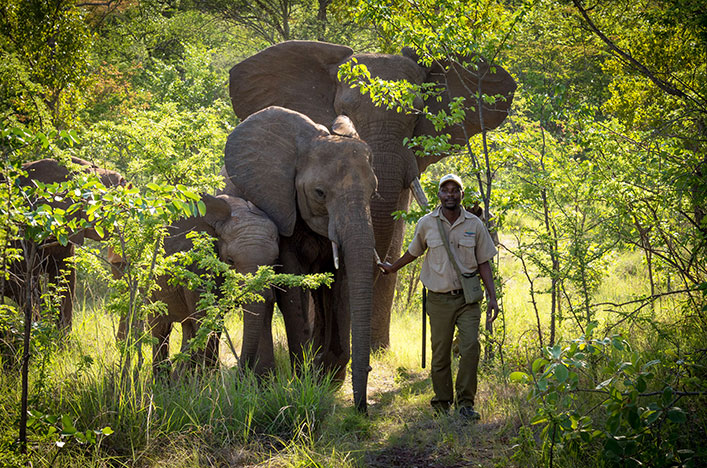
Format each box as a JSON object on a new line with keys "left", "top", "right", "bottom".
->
{"left": 427, "top": 291, "right": 481, "bottom": 409}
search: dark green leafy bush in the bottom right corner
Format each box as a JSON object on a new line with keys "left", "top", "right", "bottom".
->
{"left": 510, "top": 322, "right": 704, "bottom": 466}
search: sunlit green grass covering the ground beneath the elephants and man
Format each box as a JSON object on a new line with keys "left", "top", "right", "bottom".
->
{"left": 0, "top": 245, "right": 704, "bottom": 467}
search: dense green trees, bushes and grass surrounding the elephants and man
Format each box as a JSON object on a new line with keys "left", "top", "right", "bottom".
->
{"left": 0, "top": 0, "right": 707, "bottom": 467}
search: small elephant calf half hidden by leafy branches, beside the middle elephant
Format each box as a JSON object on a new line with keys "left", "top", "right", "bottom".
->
{"left": 147, "top": 195, "right": 278, "bottom": 372}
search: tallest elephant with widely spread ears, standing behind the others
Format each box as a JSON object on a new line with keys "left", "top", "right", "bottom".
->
{"left": 229, "top": 41, "right": 516, "bottom": 349}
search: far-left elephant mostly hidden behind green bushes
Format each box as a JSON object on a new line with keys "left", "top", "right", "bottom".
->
{"left": 5, "top": 157, "right": 127, "bottom": 332}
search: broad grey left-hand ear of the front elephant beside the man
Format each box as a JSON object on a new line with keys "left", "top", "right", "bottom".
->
{"left": 224, "top": 107, "right": 329, "bottom": 236}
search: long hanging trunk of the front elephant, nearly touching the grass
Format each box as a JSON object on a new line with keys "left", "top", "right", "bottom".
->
{"left": 339, "top": 205, "right": 375, "bottom": 412}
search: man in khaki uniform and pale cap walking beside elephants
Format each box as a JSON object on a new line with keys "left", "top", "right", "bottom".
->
{"left": 378, "top": 174, "right": 498, "bottom": 420}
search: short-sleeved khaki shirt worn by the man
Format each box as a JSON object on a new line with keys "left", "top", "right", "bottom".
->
{"left": 408, "top": 206, "right": 498, "bottom": 293}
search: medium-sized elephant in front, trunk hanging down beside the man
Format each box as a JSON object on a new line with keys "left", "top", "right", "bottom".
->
{"left": 225, "top": 107, "right": 376, "bottom": 411}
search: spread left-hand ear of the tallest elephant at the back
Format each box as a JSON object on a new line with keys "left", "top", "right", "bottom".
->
{"left": 229, "top": 41, "right": 353, "bottom": 125}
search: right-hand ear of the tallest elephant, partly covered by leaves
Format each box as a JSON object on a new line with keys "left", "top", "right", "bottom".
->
{"left": 403, "top": 48, "right": 516, "bottom": 144}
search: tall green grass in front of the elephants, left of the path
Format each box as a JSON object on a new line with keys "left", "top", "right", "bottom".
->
{"left": 0, "top": 310, "right": 335, "bottom": 466}
